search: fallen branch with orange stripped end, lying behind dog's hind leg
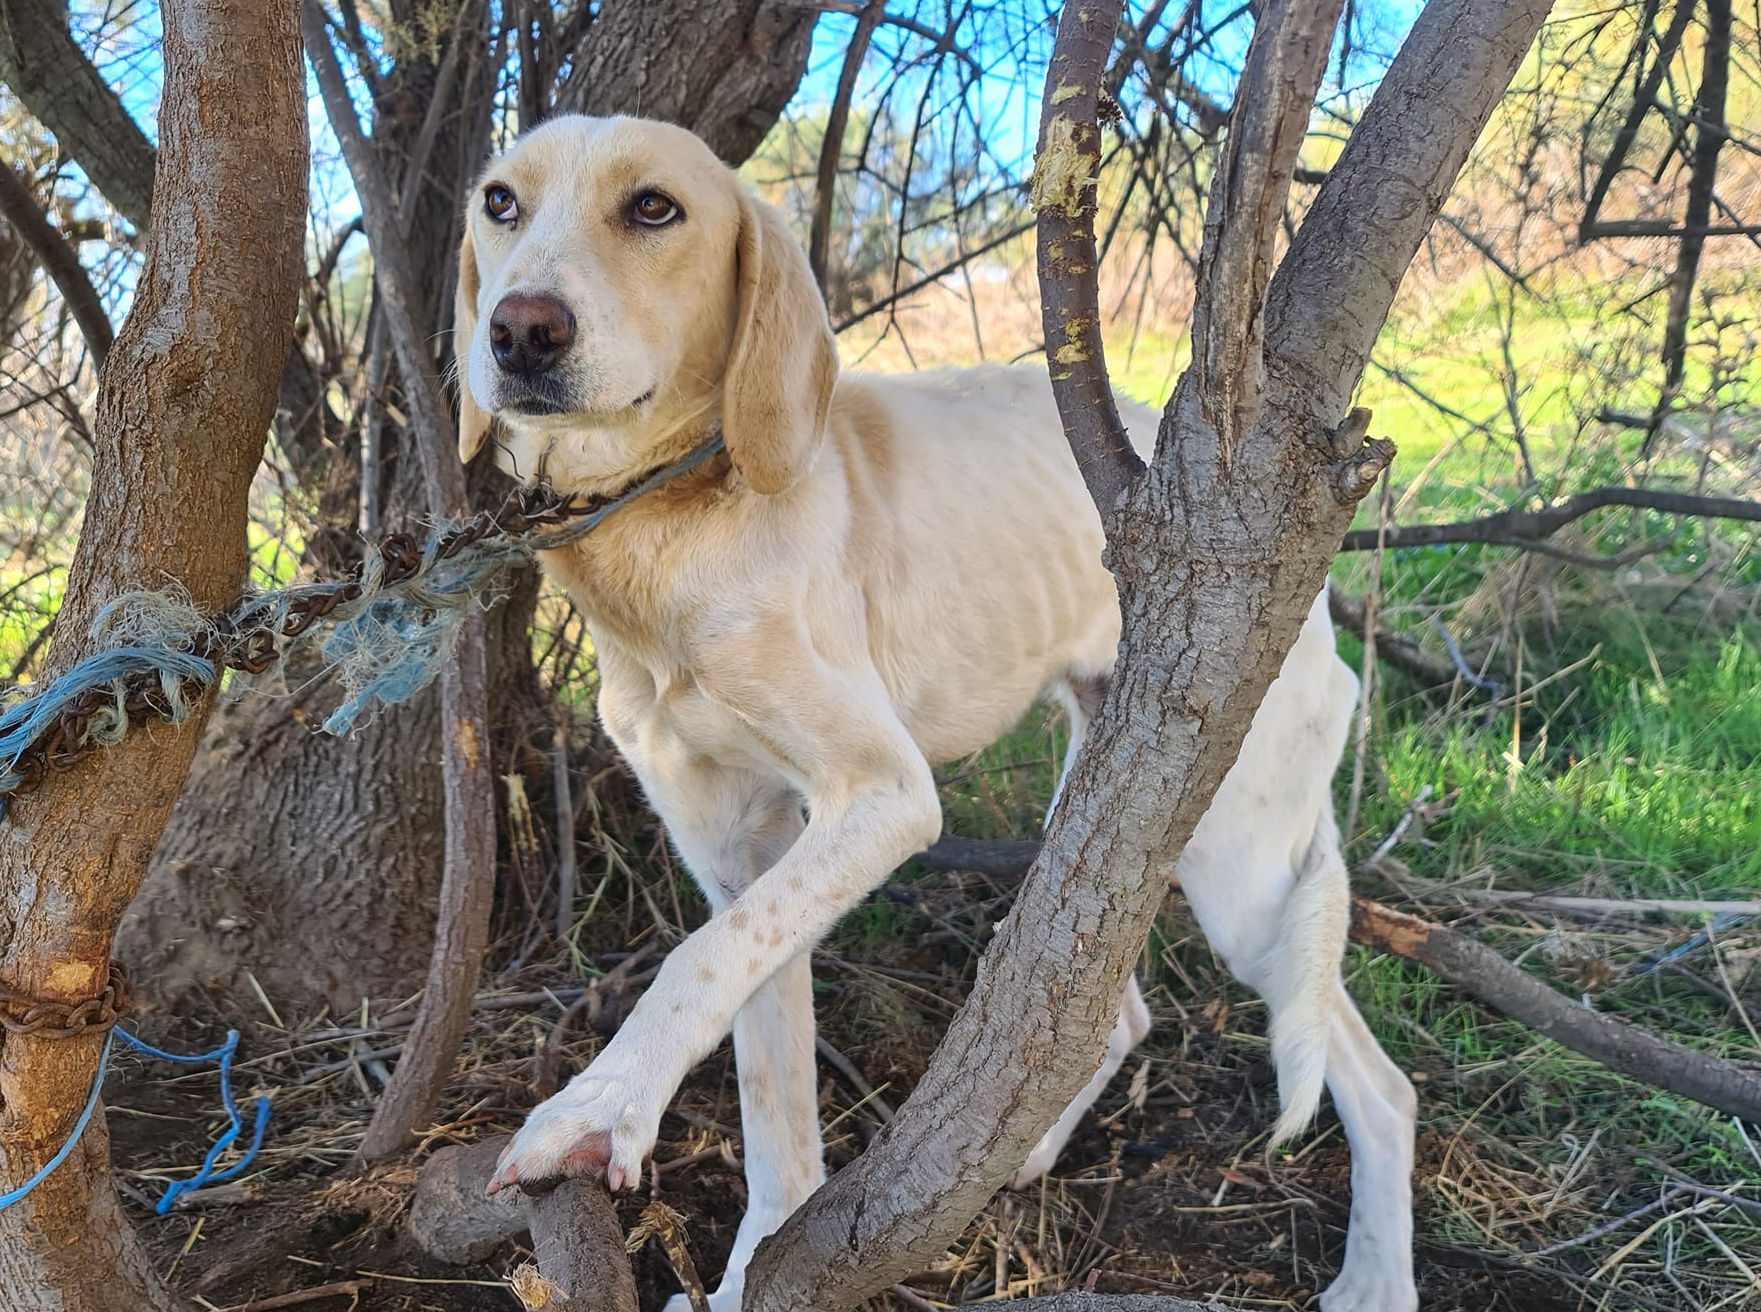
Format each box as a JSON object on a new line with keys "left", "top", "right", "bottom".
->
{"left": 917, "top": 838, "right": 1761, "bottom": 1124}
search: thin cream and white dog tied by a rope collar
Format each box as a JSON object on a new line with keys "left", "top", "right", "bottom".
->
{"left": 454, "top": 116, "right": 1418, "bottom": 1312}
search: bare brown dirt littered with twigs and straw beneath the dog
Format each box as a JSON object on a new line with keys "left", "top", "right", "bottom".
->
{"left": 109, "top": 886, "right": 1598, "bottom": 1312}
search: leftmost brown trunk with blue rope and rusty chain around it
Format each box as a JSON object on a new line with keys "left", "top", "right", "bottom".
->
{"left": 0, "top": 0, "right": 306, "bottom": 1312}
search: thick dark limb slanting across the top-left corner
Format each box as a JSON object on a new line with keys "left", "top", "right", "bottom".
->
{"left": 0, "top": 0, "right": 153, "bottom": 229}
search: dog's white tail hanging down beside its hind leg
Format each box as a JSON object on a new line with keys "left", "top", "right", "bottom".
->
{"left": 1261, "top": 803, "right": 1351, "bottom": 1146}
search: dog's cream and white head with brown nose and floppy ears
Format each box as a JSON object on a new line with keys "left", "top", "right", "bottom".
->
{"left": 453, "top": 116, "right": 838, "bottom": 493}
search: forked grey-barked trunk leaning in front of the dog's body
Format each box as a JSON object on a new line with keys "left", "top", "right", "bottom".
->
{"left": 747, "top": 0, "right": 1548, "bottom": 1312}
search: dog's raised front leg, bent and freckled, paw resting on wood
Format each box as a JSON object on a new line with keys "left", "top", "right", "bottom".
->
{"left": 491, "top": 683, "right": 940, "bottom": 1189}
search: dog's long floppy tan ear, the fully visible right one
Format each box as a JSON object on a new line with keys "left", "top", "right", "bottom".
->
{"left": 722, "top": 192, "right": 838, "bottom": 495}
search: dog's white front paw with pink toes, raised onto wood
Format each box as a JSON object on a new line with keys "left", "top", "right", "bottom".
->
{"left": 490, "top": 1071, "right": 660, "bottom": 1194}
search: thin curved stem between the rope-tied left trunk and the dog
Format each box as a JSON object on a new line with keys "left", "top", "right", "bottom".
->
{"left": 301, "top": 0, "right": 495, "bottom": 1161}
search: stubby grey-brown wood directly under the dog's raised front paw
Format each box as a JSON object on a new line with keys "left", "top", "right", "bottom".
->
{"left": 409, "top": 1134, "right": 636, "bottom": 1312}
